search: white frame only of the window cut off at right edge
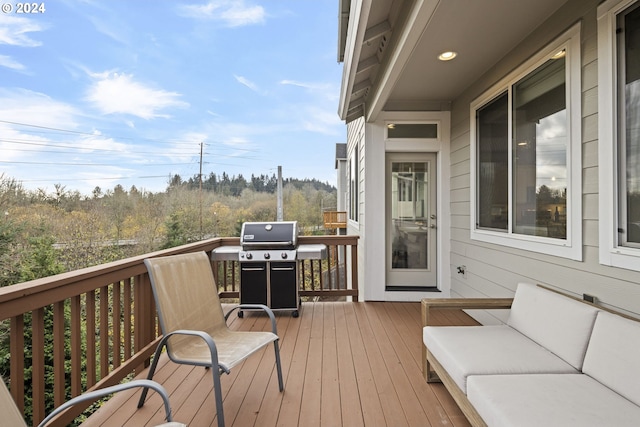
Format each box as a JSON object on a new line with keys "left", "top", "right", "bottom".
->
{"left": 597, "top": 0, "right": 640, "bottom": 271}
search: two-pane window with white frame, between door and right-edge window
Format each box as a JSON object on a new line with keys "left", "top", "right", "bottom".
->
{"left": 471, "top": 27, "right": 581, "bottom": 259}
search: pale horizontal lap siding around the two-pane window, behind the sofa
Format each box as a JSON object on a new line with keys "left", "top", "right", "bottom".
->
{"left": 451, "top": 0, "right": 640, "bottom": 323}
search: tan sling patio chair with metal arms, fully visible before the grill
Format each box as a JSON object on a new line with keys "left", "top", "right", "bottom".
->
{"left": 138, "top": 252, "right": 284, "bottom": 427}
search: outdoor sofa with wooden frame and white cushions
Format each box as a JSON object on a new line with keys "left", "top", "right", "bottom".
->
{"left": 422, "top": 283, "right": 640, "bottom": 427}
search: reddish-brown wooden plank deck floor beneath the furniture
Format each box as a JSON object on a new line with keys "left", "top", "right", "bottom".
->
{"left": 83, "top": 302, "right": 473, "bottom": 427}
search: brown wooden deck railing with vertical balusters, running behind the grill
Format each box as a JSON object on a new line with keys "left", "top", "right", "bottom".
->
{"left": 0, "top": 236, "right": 358, "bottom": 426}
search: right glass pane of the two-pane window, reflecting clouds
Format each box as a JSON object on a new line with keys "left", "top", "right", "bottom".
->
{"left": 512, "top": 56, "right": 568, "bottom": 239}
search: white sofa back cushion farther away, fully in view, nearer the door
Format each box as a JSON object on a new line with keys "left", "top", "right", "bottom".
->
{"left": 507, "top": 283, "right": 599, "bottom": 370}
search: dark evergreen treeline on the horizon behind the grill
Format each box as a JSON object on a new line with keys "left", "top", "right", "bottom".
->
{"left": 169, "top": 172, "right": 335, "bottom": 197}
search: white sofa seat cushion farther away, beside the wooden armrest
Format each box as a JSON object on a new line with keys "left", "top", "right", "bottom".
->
{"left": 423, "top": 325, "right": 578, "bottom": 393}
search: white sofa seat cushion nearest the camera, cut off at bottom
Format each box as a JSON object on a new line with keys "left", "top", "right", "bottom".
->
{"left": 467, "top": 374, "right": 640, "bottom": 427}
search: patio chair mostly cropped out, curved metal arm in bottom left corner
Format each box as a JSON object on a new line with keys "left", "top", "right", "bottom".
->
{"left": 0, "top": 378, "right": 186, "bottom": 427}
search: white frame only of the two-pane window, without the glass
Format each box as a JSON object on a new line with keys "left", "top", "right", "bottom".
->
{"left": 470, "top": 23, "right": 582, "bottom": 261}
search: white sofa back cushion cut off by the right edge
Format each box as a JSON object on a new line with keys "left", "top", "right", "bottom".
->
{"left": 583, "top": 311, "right": 640, "bottom": 406}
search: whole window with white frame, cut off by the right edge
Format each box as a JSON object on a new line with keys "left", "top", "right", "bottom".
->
{"left": 598, "top": 0, "right": 640, "bottom": 270}
